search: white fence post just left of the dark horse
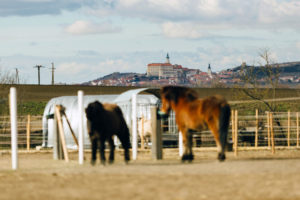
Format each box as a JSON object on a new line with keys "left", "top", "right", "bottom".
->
{"left": 78, "top": 90, "right": 84, "bottom": 165}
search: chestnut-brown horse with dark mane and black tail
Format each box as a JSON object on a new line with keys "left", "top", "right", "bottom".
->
{"left": 159, "top": 86, "right": 230, "bottom": 161}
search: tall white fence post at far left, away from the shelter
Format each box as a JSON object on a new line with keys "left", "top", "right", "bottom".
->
{"left": 9, "top": 87, "right": 18, "bottom": 170}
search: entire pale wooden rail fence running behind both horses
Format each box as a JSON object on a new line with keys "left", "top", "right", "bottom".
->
{"left": 0, "top": 110, "right": 300, "bottom": 155}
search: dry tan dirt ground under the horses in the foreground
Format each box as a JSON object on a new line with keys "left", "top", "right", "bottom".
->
{"left": 0, "top": 149, "right": 300, "bottom": 200}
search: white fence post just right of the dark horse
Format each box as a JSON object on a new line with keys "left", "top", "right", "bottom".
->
{"left": 131, "top": 94, "right": 138, "bottom": 160}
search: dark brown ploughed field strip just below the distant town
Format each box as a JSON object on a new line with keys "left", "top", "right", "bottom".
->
{"left": 0, "top": 85, "right": 300, "bottom": 101}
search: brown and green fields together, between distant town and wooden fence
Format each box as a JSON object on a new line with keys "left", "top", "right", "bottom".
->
{"left": 0, "top": 85, "right": 300, "bottom": 115}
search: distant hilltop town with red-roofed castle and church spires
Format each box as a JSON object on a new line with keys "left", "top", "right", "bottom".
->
{"left": 84, "top": 54, "right": 300, "bottom": 87}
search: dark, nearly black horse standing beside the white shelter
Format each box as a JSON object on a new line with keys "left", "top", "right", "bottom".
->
{"left": 85, "top": 101, "right": 130, "bottom": 165}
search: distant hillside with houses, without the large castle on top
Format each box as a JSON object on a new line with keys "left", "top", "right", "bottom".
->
{"left": 83, "top": 62, "right": 300, "bottom": 87}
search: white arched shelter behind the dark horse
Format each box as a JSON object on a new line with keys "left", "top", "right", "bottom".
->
{"left": 42, "top": 88, "right": 159, "bottom": 160}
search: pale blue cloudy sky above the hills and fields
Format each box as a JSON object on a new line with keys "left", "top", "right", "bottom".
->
{"left": 0, "top": 0, "right": 300, "bottom": 84}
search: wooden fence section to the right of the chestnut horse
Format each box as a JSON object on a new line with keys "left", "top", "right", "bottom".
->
{"left": 231, "top": 110, "right": 300, "bottom": 155}
